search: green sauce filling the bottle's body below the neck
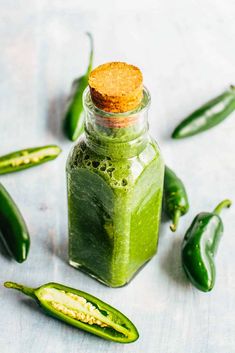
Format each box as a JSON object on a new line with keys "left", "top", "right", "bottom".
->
{"left": 67, "top": 132, "right": 164, "bottom": 287}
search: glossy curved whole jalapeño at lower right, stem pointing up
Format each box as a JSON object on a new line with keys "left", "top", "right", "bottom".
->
{"left": 182, "top": 200, "right": 231, "bottom": 292}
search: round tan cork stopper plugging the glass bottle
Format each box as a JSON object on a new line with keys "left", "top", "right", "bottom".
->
{"left": 88, "top": 62, "right": 143, "bottom": 113}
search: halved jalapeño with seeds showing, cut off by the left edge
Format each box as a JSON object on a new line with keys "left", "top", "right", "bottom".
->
{"left": 0, "top": 145, "right": 61, "bottom": 174}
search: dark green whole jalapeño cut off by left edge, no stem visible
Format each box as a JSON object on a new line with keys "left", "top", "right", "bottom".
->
{"left": 0, "top": 183, "right": 30, "bottom": 263}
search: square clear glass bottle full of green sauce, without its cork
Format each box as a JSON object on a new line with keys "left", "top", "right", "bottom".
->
{"left": 67, "top": 88, "right": 164, "bottom": 287}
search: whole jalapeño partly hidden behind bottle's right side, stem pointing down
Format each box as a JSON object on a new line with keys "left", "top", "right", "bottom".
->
{"left": 163, "top": 166, "right": 189, "bottom": 232}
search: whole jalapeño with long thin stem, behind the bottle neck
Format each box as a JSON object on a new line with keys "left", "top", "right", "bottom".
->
{"left": 64, "top": 33, "right": 94, "bottom": 141}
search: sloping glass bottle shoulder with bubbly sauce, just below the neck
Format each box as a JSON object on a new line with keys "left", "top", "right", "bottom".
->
{"left": 67, "top": 136, "right": 164, "bottom": 188}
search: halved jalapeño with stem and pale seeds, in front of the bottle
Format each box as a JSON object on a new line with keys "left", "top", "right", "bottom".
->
{"left": 4, "top": 282, "right": 139, "bottom": 343}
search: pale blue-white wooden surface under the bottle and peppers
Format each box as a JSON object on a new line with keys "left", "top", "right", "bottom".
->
{"left": 0, "top": 0, "right": 235, "bottom": 353}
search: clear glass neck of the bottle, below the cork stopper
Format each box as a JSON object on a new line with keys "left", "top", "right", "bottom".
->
{"left": 83, "top": 88, "right": 150, "bottom": 158}
